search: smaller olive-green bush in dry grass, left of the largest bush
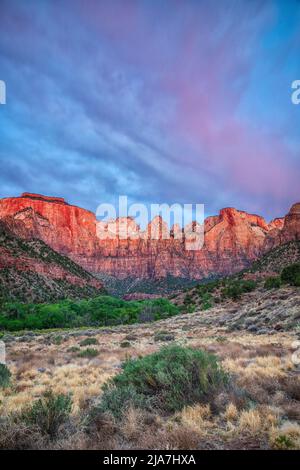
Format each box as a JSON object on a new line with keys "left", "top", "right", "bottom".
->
{"left": 22, "top": 390, "right": 72, "bottom": 439}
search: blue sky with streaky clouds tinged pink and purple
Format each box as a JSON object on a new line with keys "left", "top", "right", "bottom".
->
{"left": 0, "top": 0, "right": 300, "bottom": 219}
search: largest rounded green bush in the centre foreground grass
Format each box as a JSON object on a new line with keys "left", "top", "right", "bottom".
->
{"left": 98, "top": 345, "right": 228, "bottom": 418}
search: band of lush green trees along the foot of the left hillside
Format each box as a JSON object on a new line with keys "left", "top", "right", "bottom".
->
{"left": 0, "top": 295, "right": 179, "bottom": 331}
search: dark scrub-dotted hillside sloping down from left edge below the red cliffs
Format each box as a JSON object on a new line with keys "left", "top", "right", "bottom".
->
{"left": 0, "top": 221, "right": 104, "bottom": 302}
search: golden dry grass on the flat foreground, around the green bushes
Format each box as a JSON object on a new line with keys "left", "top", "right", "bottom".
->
{"left": 0, "top": 314, "right": 300, "bottom": 450}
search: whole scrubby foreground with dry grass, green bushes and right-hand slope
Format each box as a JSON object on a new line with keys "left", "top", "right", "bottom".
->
{"left": 0, "top": 285, "right": 300, "bottom": 450}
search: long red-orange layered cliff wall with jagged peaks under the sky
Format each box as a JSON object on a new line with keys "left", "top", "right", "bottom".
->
{"left": 0, "top": 193, "right": 300, "bottom": 279}
